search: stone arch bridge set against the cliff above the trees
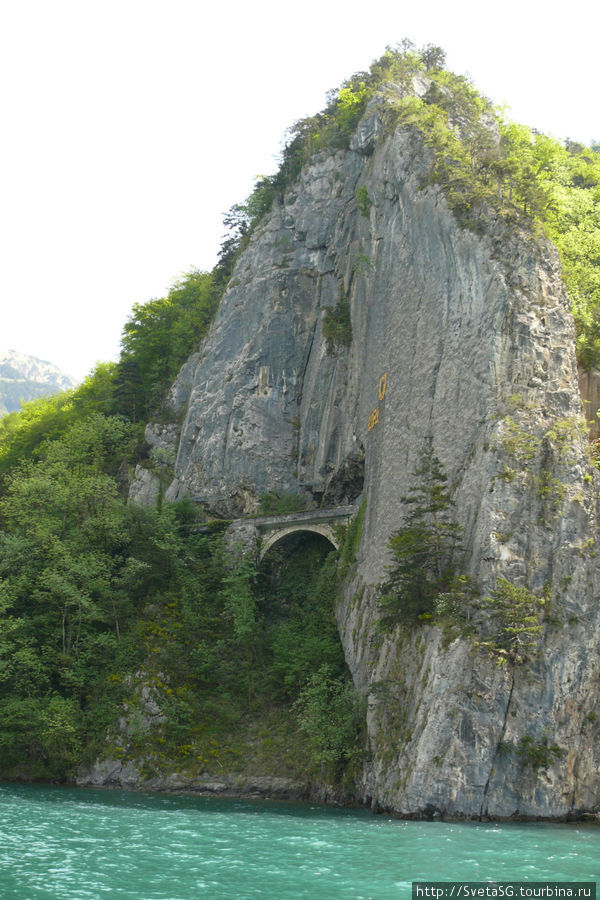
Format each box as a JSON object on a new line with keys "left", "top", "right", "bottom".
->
{"left": 225, "top": 504, "right": 358, "bottom": 562}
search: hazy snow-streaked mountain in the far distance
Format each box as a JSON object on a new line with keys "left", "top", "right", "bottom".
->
{"left": 0, "top": 350, "right": 77, "bottom": 416}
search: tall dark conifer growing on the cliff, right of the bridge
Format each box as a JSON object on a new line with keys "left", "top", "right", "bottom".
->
{"left": 380, "top": 448, "right": 470, "bottom": 629}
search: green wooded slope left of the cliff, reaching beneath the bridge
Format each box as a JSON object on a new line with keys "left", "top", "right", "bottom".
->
{"left": 0, "top": 272, "right": 361, "bottom": 780}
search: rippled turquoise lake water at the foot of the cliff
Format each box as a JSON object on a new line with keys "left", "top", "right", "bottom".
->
{"left": 0, "top": 785, "right": 600, "bottom": 900}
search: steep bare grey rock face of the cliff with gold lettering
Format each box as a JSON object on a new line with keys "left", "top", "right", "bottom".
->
{"left": 138, "top": 95, "right": 600, "bottom": 817}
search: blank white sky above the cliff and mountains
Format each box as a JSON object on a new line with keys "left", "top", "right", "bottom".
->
{"left": 0, "top": 0, "right": 600, "bottom": 378}
